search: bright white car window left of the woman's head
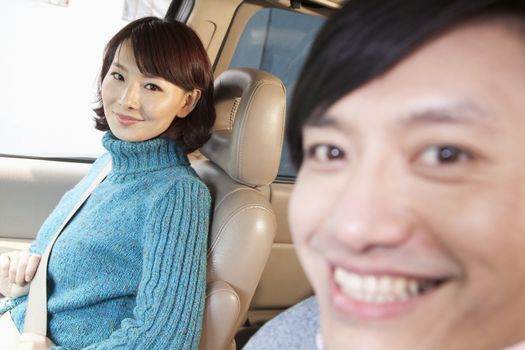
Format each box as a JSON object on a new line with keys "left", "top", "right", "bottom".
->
{"left": 0, "top": 0, "right": 127, "bottom": 157}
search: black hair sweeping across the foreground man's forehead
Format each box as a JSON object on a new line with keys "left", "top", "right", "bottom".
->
{"left": 286, "top": 0, "right": 525, "bottom": 167}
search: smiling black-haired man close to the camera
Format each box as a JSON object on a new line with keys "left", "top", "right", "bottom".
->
{"left": 246, "top": 0, "right": 525, "bottom": 350}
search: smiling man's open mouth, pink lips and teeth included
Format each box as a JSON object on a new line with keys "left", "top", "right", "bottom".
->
{"left": 331, "top": 267, "right": 445, "bottom": 320}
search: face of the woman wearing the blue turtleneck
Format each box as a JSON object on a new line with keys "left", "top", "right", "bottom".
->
{"left": 102, "top": 41, "right": 196, "bottom": 142}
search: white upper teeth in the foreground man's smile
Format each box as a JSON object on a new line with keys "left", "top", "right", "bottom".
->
{"left": 335, "top": 267, "right": 437, "bottom": 304}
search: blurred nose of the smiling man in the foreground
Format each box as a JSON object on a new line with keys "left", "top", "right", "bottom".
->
{"left": 325, "top": 159, "right": 414, "bottom": 253}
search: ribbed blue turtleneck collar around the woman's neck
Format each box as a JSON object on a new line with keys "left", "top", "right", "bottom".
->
{"left": 102, "top": 131, "right": 189, "bottom": 173}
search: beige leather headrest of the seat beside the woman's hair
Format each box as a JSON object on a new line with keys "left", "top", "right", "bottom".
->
{"left": 201, "top": 68, "right": 286, "bottom": 186}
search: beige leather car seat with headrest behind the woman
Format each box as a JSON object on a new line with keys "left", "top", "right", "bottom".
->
{"left": 193, "top": 68, "right": 286, "bottom": 350}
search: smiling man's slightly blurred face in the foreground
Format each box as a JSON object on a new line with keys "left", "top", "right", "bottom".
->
{"left": 289, "top": 23, "right": 525, "bottom": 350}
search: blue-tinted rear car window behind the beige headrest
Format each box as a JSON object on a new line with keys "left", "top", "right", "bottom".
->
{"left": 230, "top": 8, "right": 324, "bottom": 178}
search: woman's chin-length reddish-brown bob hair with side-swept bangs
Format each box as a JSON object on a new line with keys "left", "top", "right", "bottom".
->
{"left": 94, "top": 17, "right": 215, "bottom": 153}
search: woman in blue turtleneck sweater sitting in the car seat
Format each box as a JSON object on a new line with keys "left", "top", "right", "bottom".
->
{"left": 0, "top": 17, "right": 215, "bottom": 349}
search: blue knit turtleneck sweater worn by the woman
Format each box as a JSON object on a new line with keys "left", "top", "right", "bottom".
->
{"left": 0, "top": 132, "right": 211, "bottom": 350}
